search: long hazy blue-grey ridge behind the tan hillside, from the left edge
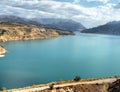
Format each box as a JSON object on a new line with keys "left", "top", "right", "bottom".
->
{"left": 0, "top": 15, "right": 85, "bottom": 31}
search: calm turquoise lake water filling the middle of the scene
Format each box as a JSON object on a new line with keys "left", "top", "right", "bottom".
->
{"left": 0, "top": 34, "right": 120, "bottom": 88}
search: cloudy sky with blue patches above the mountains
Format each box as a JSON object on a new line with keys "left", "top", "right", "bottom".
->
{"left": 0, "top": 0, "right": 120, "bottom": 28}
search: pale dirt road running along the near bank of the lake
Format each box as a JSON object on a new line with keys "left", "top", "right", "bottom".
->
{"left": 8, "top": 78, "right": 117, "bottom": 92}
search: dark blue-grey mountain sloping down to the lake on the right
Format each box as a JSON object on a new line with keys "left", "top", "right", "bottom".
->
{"left": 82, "top": 21, "right": 120, "bottom": 35}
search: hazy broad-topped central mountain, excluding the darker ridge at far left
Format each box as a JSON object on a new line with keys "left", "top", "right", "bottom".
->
{"left": 32, "top": 18, "right": 85, "bottom": 31}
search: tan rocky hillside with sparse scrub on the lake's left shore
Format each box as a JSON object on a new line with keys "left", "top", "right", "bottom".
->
{"left": 0, "top": 21, "right": 73, "bottom": 42}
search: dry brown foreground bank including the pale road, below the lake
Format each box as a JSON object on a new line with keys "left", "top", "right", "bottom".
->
{"left": 5, "top": 77, "right": 119, "bottom": 92}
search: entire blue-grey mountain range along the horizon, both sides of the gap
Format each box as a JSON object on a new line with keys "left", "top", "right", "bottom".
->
{"left": 0, "top": 15, "right": 120, "bottom": 35}
